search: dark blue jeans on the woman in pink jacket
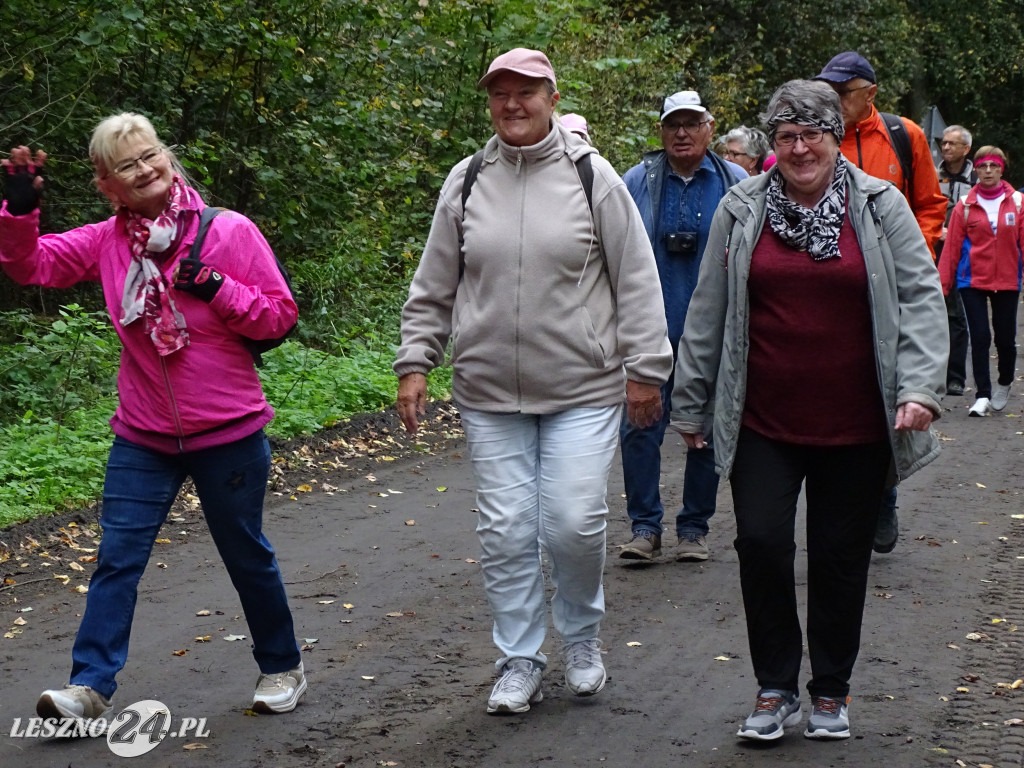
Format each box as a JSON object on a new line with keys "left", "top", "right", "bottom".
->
{"left": 71, "top": 430, "right": 301, "bottom": 698}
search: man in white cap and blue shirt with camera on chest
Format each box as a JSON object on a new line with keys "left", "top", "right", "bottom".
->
{"left": 620, "top": 91, "right": 746, "bottom": 561}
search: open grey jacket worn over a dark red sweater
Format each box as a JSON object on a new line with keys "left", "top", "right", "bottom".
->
{"left": 672, "top": 160, "right": 949, "bottom": 481}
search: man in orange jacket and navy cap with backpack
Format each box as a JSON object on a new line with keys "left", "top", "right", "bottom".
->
{"left": 813, "top": 50, "right": 946, "bottom": 554}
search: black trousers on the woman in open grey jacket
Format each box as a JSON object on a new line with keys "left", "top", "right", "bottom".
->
{"left": 730, "top": 428, "right": 892, "bottom": 696}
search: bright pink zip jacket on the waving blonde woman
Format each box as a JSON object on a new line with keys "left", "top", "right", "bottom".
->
{"left": 0, "top": 190, "right": 298, "bottom": 453}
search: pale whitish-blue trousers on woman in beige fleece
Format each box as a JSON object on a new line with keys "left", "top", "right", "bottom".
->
{"left": 459, "top": 406, "right": 622, "bottom": 672}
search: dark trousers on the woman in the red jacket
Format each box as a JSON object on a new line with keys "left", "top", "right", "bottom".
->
{"left": 959, "top": 288, "right": 1020, "bottom": 397}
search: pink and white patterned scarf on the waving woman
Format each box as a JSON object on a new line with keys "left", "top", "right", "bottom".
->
{"left": 121, "top": 175, "right": 193, "bottom": 356}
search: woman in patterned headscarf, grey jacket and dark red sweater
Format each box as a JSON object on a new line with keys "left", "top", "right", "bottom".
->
{"left": 672, "top": 80, "right": 949, "bottom": 739}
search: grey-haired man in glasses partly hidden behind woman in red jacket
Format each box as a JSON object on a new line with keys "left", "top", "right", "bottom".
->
{"left": 935, "top": 125, "right": 978, "bottom": 395}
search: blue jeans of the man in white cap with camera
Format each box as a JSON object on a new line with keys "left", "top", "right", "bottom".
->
{"left": 618, "top": 376, "right": 718, "bottom": 539}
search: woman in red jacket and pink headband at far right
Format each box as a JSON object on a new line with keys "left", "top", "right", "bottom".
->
{"left": 939, "top": 146, "right": 1024, "bottom": 416}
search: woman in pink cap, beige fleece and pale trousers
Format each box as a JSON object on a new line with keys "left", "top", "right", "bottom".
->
{"left": 394, "top": 48, "right": 672, "bottom": 714}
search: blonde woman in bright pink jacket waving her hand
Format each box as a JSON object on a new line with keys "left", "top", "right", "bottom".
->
{"left": 0, "top": 113, "right": 306, "bottom": 723}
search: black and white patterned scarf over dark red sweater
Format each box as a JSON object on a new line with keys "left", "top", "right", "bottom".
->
{"left": 767, "top": 155, "right": 846, "bottom": 261}
